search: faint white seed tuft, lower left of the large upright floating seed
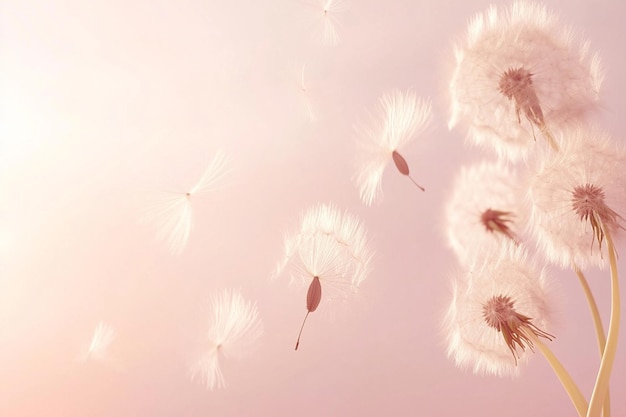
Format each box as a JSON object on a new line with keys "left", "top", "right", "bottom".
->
{"left": 190, "top": 290, "right": 263, "bottom": 390}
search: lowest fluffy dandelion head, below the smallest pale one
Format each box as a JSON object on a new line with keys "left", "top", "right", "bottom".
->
{"left": 445, "top": 243, "right": 553, "bottom": 376}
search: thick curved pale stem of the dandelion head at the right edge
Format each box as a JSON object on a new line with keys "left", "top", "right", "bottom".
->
{"left": 587, "top": 228, "right": 620, "bottom": 417}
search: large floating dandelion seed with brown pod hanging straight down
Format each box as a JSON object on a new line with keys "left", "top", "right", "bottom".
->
{"left": 273, "top": 204, "right": 372, "bottom": 349}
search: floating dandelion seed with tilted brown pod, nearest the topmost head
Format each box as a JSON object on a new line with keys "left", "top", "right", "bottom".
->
{"left": 354, "top": 90, "right": 432, "bottom": 206}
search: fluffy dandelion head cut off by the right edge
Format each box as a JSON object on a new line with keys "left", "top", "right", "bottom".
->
{"left": 528, "top": 126, "right": 626, "bottom": 269}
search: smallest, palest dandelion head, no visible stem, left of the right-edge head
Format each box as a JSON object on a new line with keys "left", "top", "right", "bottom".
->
{"left": 445, "top": 162, "right": 528, "bottom": 266}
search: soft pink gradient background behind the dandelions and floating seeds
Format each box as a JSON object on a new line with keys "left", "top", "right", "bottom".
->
{"left": 0, "top": 0, "right": 626, "bottom": 417}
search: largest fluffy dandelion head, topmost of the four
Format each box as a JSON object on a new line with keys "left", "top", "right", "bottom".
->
{"left": 448, "top": 1, "right": 603, "bottom": 160}
